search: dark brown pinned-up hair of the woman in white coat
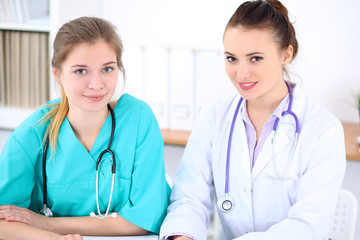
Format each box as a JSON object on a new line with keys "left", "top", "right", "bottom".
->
{"left": 225, "top": 0, "right": 299, "bottom": 59}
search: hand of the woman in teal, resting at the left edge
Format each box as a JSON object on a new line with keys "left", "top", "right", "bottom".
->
{"left": 0, "top": 205, "right": 51, "bottom": 230}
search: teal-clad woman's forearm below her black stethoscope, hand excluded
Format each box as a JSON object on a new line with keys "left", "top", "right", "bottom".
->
{"left": 47, "top": 213, "right": 147, "bottom": 236}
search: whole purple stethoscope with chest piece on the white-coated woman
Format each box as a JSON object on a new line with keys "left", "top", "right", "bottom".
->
{"left": 217, "top": 81, "right": 300, "bottom": 212}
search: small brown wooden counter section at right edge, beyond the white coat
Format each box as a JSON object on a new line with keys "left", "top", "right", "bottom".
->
{"left": 342, "top": 122, "right": 360, "bottom": 161}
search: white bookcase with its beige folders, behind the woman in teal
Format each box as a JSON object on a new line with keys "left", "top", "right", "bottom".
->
{"left": 0, "top": 0, "right": 102, "bottom": 129}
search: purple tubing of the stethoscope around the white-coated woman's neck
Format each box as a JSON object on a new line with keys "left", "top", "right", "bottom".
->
{"left": 225, "top": 81, "right": 300, "bottom": 195}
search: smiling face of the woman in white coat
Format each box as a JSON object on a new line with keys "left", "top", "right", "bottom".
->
{"left": 224, "top": 26, "right": 292, "bottom": 102}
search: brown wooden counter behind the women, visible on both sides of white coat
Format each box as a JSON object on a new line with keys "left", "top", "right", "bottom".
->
{"left": 161, "top": 122, "right": 360, "bottom": 161}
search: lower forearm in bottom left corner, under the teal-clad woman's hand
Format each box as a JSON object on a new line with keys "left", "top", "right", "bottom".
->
{"left": 0, "top": 219, "right": 61, "bottom": 240}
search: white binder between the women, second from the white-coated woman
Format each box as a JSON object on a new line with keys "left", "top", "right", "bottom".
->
{"left": 169, "top": 49, "right": 194, "bottom": 130}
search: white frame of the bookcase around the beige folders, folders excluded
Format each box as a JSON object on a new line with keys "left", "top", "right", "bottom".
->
{"left": 0, "top": 0, "right": 103, "bottom": 130}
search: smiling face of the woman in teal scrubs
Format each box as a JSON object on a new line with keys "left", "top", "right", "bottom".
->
{"left": 53, "top": 41, "right": 119, "bottom": 115}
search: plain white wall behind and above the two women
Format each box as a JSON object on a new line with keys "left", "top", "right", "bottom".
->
{"left": 102, "top": 0, "right": 360, "bottom": 122}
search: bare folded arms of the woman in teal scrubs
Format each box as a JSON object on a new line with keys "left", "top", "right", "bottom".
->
{"left": 0, "top": 205, "right": 147, "bottom": 239}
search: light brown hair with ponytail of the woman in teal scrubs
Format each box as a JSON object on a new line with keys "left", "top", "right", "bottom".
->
{"left": 40, "top": 17, "right": 125, "bottom": 154}
